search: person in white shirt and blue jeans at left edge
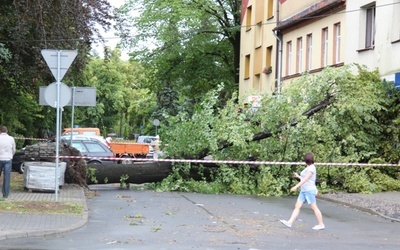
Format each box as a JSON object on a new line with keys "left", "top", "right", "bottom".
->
{"left": 0, "top": 126, "right": 15, "bottom": 198}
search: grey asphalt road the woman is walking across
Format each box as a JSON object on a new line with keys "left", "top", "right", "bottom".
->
{"left": 0, "top": 185, "right": 400, "bottom": 250}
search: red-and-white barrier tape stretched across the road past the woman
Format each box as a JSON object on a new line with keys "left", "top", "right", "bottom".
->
{"left": 54, "top": 156, "right": 400, "bottom": 167}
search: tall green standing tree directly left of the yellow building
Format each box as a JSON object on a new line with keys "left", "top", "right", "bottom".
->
{"left": 117, "top": 0, "right": 241, "bottom": 106}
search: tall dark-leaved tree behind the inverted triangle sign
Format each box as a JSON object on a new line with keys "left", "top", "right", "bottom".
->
{"left": 0, "top": 0, "right": 113, "bottom": 136}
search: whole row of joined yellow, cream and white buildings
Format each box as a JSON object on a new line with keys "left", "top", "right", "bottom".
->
{"left": 239, "top": 0, "right": 400, "bottom": 98}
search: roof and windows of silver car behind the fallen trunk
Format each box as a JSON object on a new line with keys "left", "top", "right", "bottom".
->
{"left": 61, "top": 138, "right": 117, "bottom": 164}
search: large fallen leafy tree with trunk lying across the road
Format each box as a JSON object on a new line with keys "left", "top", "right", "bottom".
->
{"left": 22, "top": 66, "right": 398, "bottom": 195}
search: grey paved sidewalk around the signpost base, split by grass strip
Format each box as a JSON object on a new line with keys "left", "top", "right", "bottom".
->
{"left": 0, "top": 185, "right": 88, "bottom": 240}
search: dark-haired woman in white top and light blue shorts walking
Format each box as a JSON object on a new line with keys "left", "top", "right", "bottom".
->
{"left": 280, "top": 153, "right": 325, "bottom": 230}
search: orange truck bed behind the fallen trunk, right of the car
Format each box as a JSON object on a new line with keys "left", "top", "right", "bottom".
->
{"left": 109, "top": 142, "right": 151, "bottom": 164}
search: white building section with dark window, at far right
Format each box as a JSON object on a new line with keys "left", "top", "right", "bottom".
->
{"left": 344, "top": 0, "right": 400, "bottom": 85}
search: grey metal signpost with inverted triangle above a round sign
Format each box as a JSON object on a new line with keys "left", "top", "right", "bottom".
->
{"left": 42, "top": 49, "right": 78, "bottom": 201}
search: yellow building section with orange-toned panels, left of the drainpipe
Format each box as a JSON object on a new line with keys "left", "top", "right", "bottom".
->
{"left": 239, "top": 0, "right": 277, "bottom": 101}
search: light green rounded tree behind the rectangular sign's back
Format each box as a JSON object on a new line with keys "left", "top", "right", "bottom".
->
{"left": 76, "top": 49, "right": 156, "bottom": 137}
